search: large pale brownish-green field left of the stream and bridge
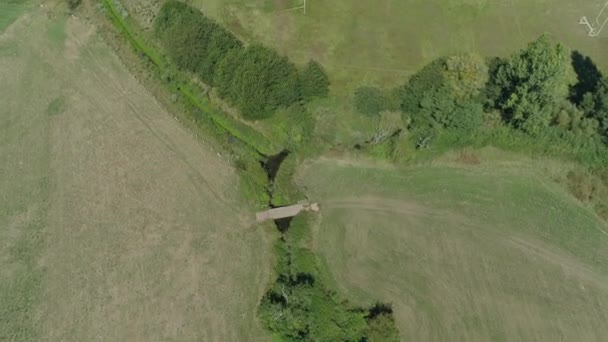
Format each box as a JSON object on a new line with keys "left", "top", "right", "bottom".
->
{"left": 0, "top": 6, "right": 271, "bottom": 341}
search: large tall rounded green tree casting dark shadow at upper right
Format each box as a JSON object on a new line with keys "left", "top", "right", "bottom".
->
{"left": 488, "top": 35, "right": 569, "bottom": 133}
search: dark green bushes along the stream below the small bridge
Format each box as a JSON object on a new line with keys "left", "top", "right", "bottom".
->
{"left": 260, "top": 216, "right": 399, "bottom": 342}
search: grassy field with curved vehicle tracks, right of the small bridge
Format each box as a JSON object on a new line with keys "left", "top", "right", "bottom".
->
{"left": 299, "top": 150, "right": 608, "bottom": 341}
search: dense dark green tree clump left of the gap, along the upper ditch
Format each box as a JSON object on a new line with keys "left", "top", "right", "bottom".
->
{"left": 154, "top": 1, "right": 329, "bottom": 119}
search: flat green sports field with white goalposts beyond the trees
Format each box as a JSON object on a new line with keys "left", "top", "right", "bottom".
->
{"left": 184, "top": 0, "right": 608, "bottom": 94}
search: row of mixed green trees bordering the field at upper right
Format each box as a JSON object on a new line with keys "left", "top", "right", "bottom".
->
{"left": 354, "top": 35, "right": 608, "bottom": 150}
